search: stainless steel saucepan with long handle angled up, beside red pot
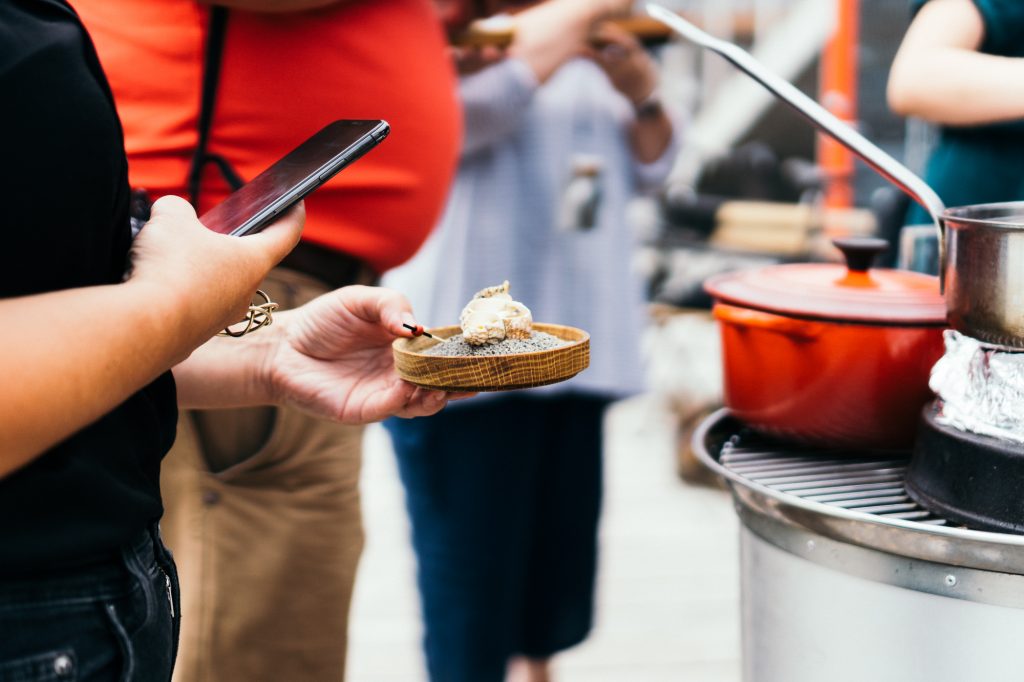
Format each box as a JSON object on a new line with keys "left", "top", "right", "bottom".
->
{"left": 647, "top": 3, "right": 1024, "bottom": 349}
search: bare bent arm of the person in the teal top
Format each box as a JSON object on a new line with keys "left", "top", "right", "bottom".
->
{"left": 888, "top": 0, "right": 1024, "bottom": 126}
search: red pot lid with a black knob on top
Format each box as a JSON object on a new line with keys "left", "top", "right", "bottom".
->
{"left": 705, "top": 238, "right": 946, "bottom": 326}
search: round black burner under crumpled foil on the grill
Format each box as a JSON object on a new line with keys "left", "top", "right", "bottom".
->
{"left": 905, "top": 406, "right": 1024, "bottom": 535}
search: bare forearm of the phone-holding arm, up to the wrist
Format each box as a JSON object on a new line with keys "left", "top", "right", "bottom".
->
{"left": 0, "top": 283, "right": 193, "bottom": 477}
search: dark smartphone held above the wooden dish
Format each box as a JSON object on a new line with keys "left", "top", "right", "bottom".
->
{"left": 200, "top": 121, "right": 391, "bottom": 237}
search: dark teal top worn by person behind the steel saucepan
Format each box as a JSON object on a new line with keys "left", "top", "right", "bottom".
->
{"left": 906, "top": 0, "right": 1024, "bottom": 224}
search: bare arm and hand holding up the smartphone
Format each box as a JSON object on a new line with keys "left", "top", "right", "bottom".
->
{"left": 0, "top": 193, "right": 302, "bottom": 477}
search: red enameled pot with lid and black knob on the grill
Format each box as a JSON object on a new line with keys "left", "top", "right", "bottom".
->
{"left": 705, "top": 239, "right": 947, "bottom": 449}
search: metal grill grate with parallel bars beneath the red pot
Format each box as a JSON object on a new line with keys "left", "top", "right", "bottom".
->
{"left": 719, "top": 434, "right": 947, "bottom": 525}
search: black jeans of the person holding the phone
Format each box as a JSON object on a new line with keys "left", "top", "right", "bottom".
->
{"left": 0, "top": 528, "right": 181, "bottom": 682}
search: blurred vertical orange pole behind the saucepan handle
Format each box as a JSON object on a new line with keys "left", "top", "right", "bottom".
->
{"left": 817, "top": 0, "right": 860, "bottom": 215}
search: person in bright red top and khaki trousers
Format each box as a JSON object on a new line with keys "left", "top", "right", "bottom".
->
{"left": 75, "top": 0, "right": 461, "bottom": 682}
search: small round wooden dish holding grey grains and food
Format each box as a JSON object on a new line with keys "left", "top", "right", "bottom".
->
{"left": 391, "top": 323, "right": 590, "bottom": 392}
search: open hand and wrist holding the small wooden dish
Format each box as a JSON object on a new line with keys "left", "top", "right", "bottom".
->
{"left": 174, "top": 287, "right": 460, "bottom": 424}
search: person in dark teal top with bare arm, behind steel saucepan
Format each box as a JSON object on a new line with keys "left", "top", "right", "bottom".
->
{"left": 888, "top": 0, "right": 1024, "bottom": 224}
